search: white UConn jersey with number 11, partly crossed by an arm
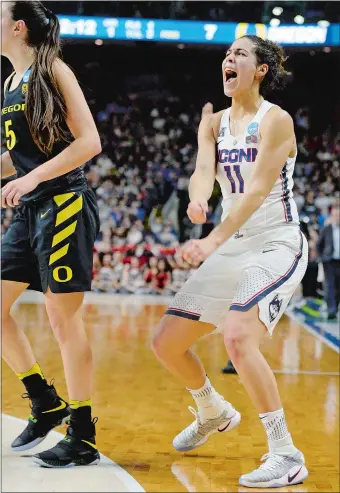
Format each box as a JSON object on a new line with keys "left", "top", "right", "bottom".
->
{"left": 216, "top": 101, "right": 299, "bottom": 229}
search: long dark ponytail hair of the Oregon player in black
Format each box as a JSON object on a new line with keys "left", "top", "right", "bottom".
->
{"left": 11, "top": 0, "right": 70, "bottom": 154}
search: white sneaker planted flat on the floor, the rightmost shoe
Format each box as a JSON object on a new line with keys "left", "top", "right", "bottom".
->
{"left": 239, "top": 450, "right": 308, "bottom": 488}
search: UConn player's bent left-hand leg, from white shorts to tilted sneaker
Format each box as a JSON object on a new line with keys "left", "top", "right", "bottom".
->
{"left": 152, "top": 256, "right": 241, "bottom": 451}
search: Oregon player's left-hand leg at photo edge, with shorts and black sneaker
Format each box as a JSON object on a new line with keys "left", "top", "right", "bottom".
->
{"left": 1, "top": 210, "right": 69, "bottom": 451}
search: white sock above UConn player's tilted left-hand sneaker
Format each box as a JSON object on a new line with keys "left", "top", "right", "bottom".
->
{"left": 188, "top": 377, "right": 226, "bottom": 421}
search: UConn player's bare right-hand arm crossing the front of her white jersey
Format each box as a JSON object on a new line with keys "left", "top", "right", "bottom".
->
{"left": 210, "top": 107, "right": 295, "bottom": 245}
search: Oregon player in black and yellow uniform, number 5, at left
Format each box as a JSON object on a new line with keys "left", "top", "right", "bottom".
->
{"left": 1, "top": 1, "right": 101, "bottom": 467}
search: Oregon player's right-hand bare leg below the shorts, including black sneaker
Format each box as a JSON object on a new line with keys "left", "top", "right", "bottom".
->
{"left": 34, "top": 290, "right": 99, "bottom": 467}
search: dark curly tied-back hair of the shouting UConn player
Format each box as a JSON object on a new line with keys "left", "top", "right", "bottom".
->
{"left": 242, "top": 34, "right": 290, "bottom": 95}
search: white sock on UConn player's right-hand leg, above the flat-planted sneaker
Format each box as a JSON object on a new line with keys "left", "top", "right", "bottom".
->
{"left": 259, "top": 409, "right": 297, "bottom": 455}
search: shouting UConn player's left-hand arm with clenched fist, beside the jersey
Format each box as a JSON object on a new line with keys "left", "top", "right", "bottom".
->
{"left": 187, "top": 108, "right": 216, "bottom": 224}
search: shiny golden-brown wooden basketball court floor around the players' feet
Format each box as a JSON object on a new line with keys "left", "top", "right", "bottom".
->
{"left": 2, "top": 293, "right": 340, "bottom": 492}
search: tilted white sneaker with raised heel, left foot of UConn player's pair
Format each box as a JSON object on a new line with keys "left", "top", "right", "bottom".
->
{"left": 172, "top": 402, "right": 241, "bottom": 452}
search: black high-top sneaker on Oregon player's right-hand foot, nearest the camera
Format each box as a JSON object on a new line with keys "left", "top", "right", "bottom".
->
{"left": 33, "top": 418, "right": 100, "bottom": 468}
